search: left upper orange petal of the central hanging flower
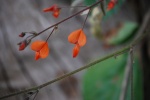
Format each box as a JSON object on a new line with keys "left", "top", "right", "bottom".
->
{"left": 68, "top": 29, "right": 82, "bottom": 44}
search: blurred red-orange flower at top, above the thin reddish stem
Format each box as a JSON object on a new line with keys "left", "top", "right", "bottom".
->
{"left": 43, "top": 5, "right": 61, "bottom": 18}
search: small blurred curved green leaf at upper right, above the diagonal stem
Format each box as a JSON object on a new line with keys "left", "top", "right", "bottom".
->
{"left": 108, "top": 22, "right": 138, "bottom": 45}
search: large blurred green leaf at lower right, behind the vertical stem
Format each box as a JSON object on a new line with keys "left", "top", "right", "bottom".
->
{"left": 83, "top": 54, "right": 142, "bottom": 100}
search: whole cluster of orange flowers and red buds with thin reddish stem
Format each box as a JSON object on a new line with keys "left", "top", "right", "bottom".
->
{"left": 18, "top": 0, "right": 117, "bottom": 60}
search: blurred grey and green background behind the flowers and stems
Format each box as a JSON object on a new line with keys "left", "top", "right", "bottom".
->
{"left": 0, "top": 0, "right": 150, "bottom": 100}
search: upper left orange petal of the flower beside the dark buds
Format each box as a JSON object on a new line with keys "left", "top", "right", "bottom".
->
{"left": 31, "top": 40, "right": 47, "bottom": 51}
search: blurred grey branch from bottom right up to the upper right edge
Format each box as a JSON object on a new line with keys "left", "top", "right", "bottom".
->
{"left": 119, "top": 8, "right": 150, "bottom": 100}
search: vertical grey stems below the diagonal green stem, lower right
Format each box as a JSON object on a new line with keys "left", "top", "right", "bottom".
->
{"left": 119, "top": 47, "right": 133, "bottom": 100}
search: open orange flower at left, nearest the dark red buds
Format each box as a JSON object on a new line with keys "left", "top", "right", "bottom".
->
{"left": 31, "top": 41, "right": 49, "bottom": 60}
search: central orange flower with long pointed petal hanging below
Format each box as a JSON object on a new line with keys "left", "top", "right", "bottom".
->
{"left": 68, "top": 29, "right": 86, "bottom": 58}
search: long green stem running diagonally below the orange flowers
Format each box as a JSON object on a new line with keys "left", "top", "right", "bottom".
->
{"left": 0, "top": 32, "right": 149, "bottom": 99}
